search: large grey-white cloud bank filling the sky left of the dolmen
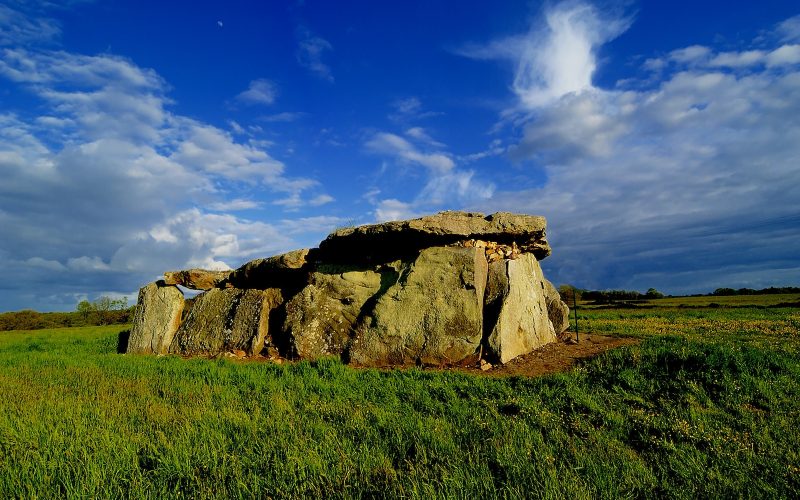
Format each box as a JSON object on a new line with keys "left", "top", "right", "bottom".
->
{"left": 0, "top": 13, "right": 324, "bottom": 310}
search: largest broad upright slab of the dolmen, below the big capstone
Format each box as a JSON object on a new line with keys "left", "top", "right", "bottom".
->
{"left": 350, "top": 247, "right": 487, "bottom": 366}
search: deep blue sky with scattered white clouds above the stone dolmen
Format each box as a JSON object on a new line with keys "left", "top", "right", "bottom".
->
{"left": 0, "top": 0, "right": 800, "bottom": 310}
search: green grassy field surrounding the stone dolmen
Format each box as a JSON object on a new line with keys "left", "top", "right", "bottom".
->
{"left": 0, "top": 308, "right": 800, "bottom": 498}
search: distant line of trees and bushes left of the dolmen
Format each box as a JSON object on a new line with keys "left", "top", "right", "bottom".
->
{"left": 0, "top": 296, "right": 135, "bottom": 331}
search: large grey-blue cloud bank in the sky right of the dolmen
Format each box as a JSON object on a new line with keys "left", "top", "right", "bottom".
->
{"left": 472, "top": 4, "right": 800, "bottom": 293}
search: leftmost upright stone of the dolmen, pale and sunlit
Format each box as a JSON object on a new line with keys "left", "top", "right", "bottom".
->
{"left": 127, "top": 281, "right": 184, "bottom": 354}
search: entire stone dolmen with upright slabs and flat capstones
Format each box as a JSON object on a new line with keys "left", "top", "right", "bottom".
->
{"left": 128, "top": 212, "right": 569, "bottom": 366}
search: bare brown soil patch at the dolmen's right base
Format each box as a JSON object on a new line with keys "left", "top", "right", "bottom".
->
{"left": 448, "top": 333, "right": 641, "bottom": 377}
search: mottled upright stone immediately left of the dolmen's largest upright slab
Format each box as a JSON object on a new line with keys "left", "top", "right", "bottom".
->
{"left": 284, "top": 265, "right": 388, "bottom": 359}
